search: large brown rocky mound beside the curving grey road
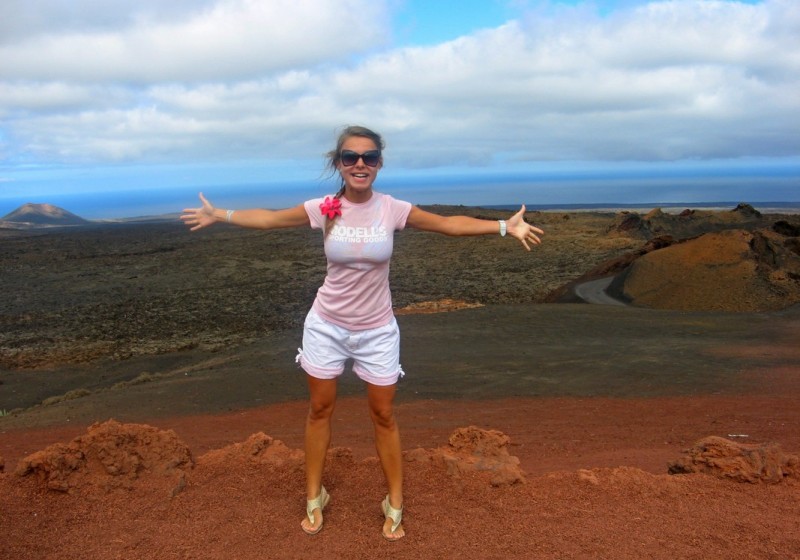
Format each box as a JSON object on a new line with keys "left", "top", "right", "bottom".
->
{"left": 609, "top": 229, "right": 800, "bottom": 311}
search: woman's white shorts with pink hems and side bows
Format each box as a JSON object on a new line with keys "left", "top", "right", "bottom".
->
{"left": 297, "top": 308, "right": 404, "bottom": 385}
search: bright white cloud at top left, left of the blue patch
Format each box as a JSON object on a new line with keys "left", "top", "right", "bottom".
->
{"left": 0, "top": 0, "right": 388, "bottom": 84}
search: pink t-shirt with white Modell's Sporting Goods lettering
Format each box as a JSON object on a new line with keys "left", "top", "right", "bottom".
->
{"left": 305, "top": 191, "right": 411, "bottom": 331}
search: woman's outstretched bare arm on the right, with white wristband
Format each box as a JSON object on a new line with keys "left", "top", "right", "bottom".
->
{"left": 406, "top": 204, "right": 544, "bottom": 251}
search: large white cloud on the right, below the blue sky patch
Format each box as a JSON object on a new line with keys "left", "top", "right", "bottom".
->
{"left": 320, "top": 1, "right": 800, "bottom": 160}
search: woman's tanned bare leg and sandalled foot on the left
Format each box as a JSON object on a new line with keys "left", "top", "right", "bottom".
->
{"left": 302, "top": 375, "right": 336, "bottom": 530}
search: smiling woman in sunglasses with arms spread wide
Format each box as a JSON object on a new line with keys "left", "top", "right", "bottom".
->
{"left": 181, "top": 126, "right": 544, "bottom": 540}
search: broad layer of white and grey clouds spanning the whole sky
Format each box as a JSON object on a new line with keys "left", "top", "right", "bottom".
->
{"left": 0, "top": 0, "right": 800, "bottom": 168}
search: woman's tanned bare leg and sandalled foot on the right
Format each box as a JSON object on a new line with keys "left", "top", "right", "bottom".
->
{"left": 367, "top": 383, "right": 405, "bottom": 539}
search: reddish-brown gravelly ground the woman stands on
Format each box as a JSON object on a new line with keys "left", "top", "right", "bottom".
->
{"left": 0, "top": 380, "right": 800, "bottom": 559}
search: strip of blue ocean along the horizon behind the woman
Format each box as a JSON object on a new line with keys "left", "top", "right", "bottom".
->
{"left": 0, "top": 176, "right": 800, "bottom": 220}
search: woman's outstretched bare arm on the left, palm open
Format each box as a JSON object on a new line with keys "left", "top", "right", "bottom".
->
{"left": 181, "top": 193, "right": 310, "bottom": 231}
